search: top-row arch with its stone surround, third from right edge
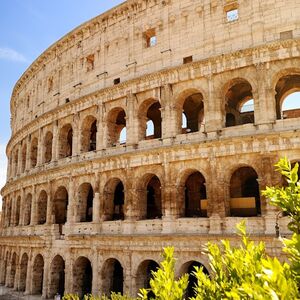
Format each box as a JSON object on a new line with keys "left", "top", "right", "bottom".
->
{"left": 176, "top": 88, "right": 205, "bottom": 134}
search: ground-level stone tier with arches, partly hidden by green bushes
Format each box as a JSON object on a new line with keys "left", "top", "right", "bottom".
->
{"left": 0, "top": 235, "right": 284, "bottom": 299}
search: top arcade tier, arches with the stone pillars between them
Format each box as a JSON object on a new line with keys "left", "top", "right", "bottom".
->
{"left": 8, "top": 66, "right": 300, "bottom": 178}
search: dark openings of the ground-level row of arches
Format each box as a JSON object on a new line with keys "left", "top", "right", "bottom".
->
{"left": 1, "top": 252, "right": 209, "bottom": 299}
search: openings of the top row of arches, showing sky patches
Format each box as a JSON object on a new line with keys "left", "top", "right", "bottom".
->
{"left": 11, "top": 74, "right": 300, "bottom": 175}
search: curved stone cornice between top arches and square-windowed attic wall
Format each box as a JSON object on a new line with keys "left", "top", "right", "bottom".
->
{"left": 6, "top": 39, "right": 300, "bottom": 154}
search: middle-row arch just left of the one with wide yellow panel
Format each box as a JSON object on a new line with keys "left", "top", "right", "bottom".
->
{"left": 178, "top": 169, "right": 207, "bottom": 218}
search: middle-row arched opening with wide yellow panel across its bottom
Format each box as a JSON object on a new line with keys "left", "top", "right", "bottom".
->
{"left": 230, "top": 167, "right": 261, "bottom": 217}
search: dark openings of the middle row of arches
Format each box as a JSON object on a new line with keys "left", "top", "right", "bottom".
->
{"left": 3, "top": 166, "right": 261, "bottom": 226}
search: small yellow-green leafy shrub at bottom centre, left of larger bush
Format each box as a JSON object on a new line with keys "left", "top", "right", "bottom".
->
{"left": 139, "top": 247, "right": 188, "bottom": 300}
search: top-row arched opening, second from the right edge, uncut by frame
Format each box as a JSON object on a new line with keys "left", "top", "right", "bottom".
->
{"left": 225, "top": 79, "right": 254, "bottom": 127}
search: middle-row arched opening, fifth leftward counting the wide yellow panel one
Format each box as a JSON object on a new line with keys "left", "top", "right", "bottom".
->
{"left": 77, "top": 183, "right": 94, "bottom": 222}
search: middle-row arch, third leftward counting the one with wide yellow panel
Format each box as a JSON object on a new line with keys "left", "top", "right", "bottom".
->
{"left": 137, "top": 173, "right": 163, "bottom": 219}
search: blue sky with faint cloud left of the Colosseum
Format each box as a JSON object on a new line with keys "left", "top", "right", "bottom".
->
{"left": 0, "top": 0, "right": 124, "bottom": 200}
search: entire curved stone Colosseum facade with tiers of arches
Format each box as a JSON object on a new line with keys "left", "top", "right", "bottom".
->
{"left": 0, "top": 0, "right": 300, "bottom": 299}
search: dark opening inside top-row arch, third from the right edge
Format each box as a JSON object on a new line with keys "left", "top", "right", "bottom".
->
{"left": 182, "top": 93, "right": 204, "bottom": 133}
